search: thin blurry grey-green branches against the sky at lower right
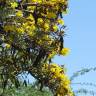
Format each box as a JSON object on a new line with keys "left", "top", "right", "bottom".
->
{"left": 70, "top": 67, "right": 96, "bottom": 96}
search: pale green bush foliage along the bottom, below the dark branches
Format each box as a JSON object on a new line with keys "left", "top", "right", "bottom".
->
{"left": 0, "top": 85, "right": 52, "bottom": 96}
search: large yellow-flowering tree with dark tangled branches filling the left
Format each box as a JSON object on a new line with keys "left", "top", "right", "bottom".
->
{"left": 0, "top": 0, "right": 73, "bottom": 96}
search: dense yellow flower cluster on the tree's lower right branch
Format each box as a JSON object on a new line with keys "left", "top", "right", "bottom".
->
{"left": 41, "top": 64, "right": 73, "bottom": 96}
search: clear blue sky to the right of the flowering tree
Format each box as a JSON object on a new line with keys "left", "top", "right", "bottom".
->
{"left": 54, "top": 0, "right": 96, "bottom": 96}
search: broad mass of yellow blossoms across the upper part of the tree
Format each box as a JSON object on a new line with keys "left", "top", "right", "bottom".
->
{"left": 4, "top": 0, "right": 68, "bottom": 47}
